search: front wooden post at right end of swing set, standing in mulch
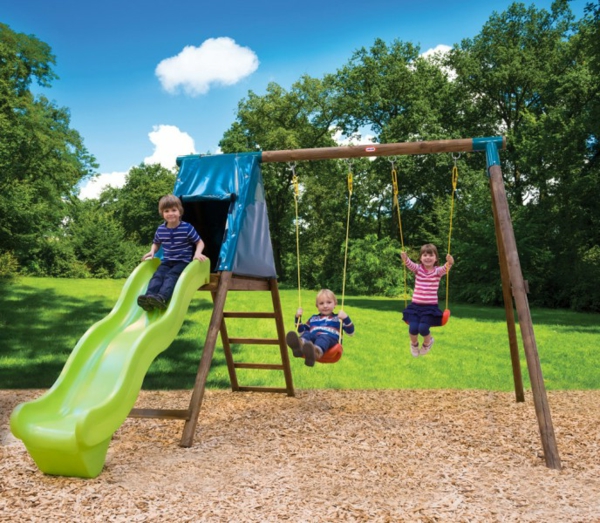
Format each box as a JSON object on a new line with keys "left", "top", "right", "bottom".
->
{"left": 488, "top": 159, "right": 561, "bottom": 470}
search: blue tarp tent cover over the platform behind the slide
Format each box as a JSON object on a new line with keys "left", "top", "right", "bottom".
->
{"left": 173, "top": 153, "right": 277, "bottom": 278}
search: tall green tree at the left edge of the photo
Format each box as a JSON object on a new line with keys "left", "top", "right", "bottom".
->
{"left": 0, "top": 24, "right": 96, "bottom": 274}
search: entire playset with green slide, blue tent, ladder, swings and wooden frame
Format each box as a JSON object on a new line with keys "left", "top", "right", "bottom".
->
{"left": 11, "top": 137, "right": 561, "bottom": 477}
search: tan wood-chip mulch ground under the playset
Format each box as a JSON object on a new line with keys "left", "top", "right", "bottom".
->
{"left": 0, "top": 390, "right": 600, "bottom": 522}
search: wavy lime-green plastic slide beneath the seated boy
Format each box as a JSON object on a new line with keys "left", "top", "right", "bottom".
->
{"left": 10, "top": 259, "right": 210, "bottom": 478}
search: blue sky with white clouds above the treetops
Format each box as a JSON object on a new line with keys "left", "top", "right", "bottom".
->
{"left": 0, "top": 0, "right": 586, "bottom": 198}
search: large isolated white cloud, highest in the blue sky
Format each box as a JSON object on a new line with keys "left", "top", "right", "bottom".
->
{"left": 155, "top": 37, "right": 259, "bottom": 96}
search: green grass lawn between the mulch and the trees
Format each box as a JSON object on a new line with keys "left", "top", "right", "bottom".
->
{"left": 0, "top": 278, "right": 600, "bottom": 391}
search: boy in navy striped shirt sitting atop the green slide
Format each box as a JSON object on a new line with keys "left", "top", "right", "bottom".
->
{"left": 137, "top": 194, "right": 208, "bottom": 311}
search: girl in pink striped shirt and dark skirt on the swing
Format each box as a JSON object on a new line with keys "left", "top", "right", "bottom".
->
{"left": 400, "top": 243, "right": 454, "bottom": 358}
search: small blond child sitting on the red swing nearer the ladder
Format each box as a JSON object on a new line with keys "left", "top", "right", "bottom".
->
{"left": 285, "top": 289, "right": 354, "bottom": 367}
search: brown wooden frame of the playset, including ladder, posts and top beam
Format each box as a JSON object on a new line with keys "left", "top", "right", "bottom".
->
{"left": 130, "top": 137, "right": 561, "bottom": 470}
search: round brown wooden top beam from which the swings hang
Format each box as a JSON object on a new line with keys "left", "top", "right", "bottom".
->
{"left": 261, "top": 136, "right": 506, "bottom": 163}
